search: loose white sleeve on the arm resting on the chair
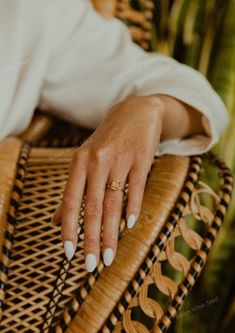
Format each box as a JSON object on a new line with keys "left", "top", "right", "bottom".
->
{"left": 40, "top": 0, "right": 227, "bottom": 155}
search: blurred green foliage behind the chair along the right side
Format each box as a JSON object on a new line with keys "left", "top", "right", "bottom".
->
{"left": 152, "top": 0, "right": 235, "bottom": 333}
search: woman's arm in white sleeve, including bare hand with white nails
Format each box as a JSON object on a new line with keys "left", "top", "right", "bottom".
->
{"left": 45, "top": 2, "right": 227, "bottom": 271}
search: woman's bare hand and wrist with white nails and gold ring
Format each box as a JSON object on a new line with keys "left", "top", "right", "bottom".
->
{"left": 53, "top": 95, "right": 206, "bottom": 272}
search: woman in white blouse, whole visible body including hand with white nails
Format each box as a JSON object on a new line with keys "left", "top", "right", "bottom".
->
{"left": 0, "top": 0, "right": 227, "bottom": 271}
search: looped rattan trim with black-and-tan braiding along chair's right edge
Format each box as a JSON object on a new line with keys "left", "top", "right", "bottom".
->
{"left": 106, "top": 154, "right": 233, "bottom": 333}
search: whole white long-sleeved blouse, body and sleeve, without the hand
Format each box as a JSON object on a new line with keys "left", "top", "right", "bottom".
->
{"left": 0, "top": 0, "right": 227, "bottom": 155}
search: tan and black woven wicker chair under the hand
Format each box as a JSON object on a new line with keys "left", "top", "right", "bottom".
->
{"left": 0, "top": 0, "right": 232, "bottom": 333}
